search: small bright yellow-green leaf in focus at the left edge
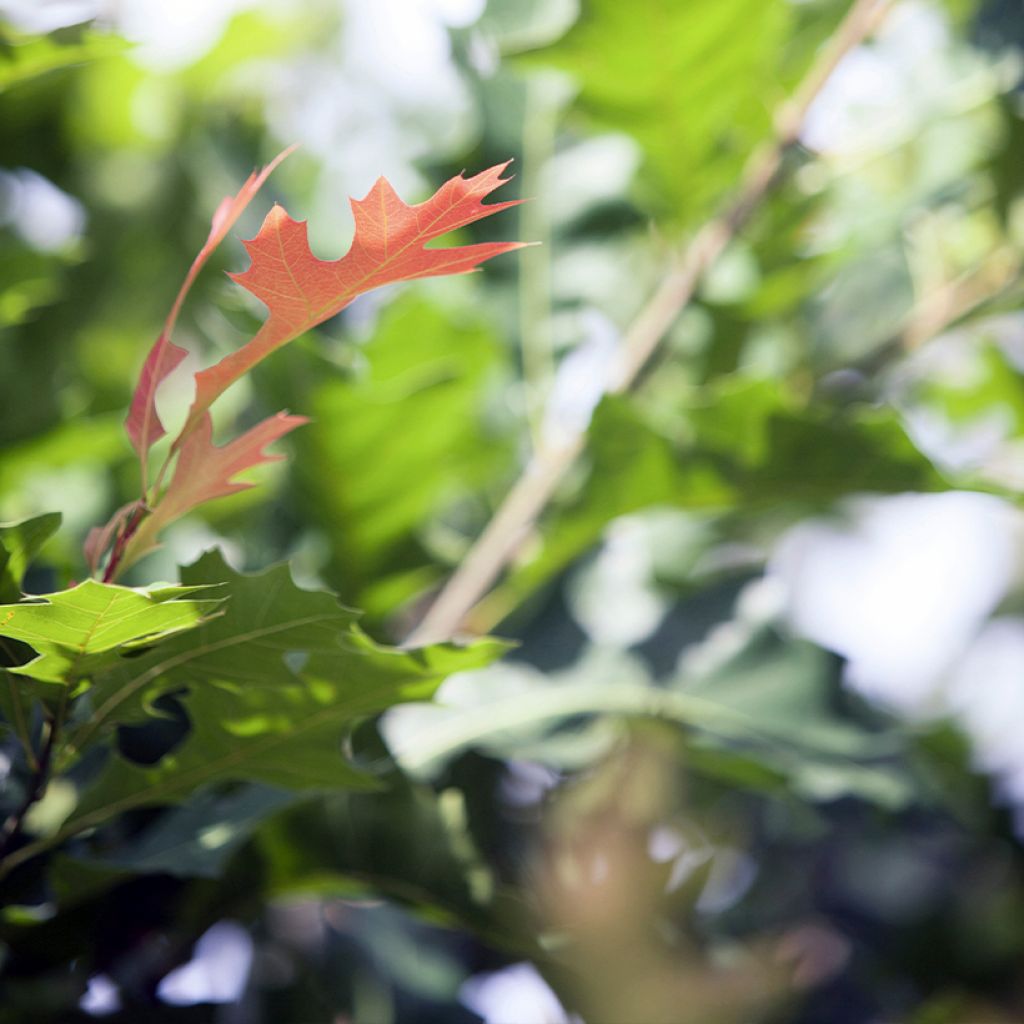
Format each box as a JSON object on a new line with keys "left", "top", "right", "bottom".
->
{"left": 0, "top": 580, "right": 220, "bottom": 685}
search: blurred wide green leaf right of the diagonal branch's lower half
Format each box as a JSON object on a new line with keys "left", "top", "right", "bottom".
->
{"left": 500, "top": 376, "right": 946, "bottom": 606}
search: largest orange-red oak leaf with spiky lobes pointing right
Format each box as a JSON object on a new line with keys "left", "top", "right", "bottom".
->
{"left": 176, "top": 163, "right": 525, "bottom": 444}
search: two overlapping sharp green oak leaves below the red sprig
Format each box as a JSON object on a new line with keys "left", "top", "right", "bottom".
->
{"left": 4, "top": 554, "right": 503, "bottom": 880}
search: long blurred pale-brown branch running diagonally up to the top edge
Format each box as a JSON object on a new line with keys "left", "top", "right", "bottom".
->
{"left": 407, "top": 0, "right": 893, "bottom": 646}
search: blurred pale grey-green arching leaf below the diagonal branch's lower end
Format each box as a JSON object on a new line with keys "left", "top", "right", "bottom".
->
{"left": 385, "top": 637, "right": 912, "bottom": 807}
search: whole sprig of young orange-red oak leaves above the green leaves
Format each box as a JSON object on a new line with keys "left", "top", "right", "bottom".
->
{"left": 94, "top": 150, "right": 523, "bottom": 581}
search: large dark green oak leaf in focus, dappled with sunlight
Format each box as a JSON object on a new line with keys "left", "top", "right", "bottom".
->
{"left": 65, "top": 553, "right": 507, "bottom": 834}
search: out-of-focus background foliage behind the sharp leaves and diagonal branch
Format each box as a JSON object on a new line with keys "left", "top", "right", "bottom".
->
{"left": 0, "top": 0, "right": 1024, "bottom": 1024}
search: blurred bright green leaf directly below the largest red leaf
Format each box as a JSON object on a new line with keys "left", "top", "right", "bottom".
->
{"left": 294, "top": 296, "right": 511, "bottom": 614}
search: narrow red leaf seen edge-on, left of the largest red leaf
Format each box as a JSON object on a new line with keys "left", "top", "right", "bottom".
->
{"left": 124, "top": 145, "right": 295, "bottom": 491}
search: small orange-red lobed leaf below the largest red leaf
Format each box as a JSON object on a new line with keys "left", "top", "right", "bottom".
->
{"left": 119, "top": 413, "right": 309, "bottom": 570}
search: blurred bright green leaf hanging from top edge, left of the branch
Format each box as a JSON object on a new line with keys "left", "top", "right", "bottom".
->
{"left": 521, "top": 0, "right": 796, "bottom": 221}
